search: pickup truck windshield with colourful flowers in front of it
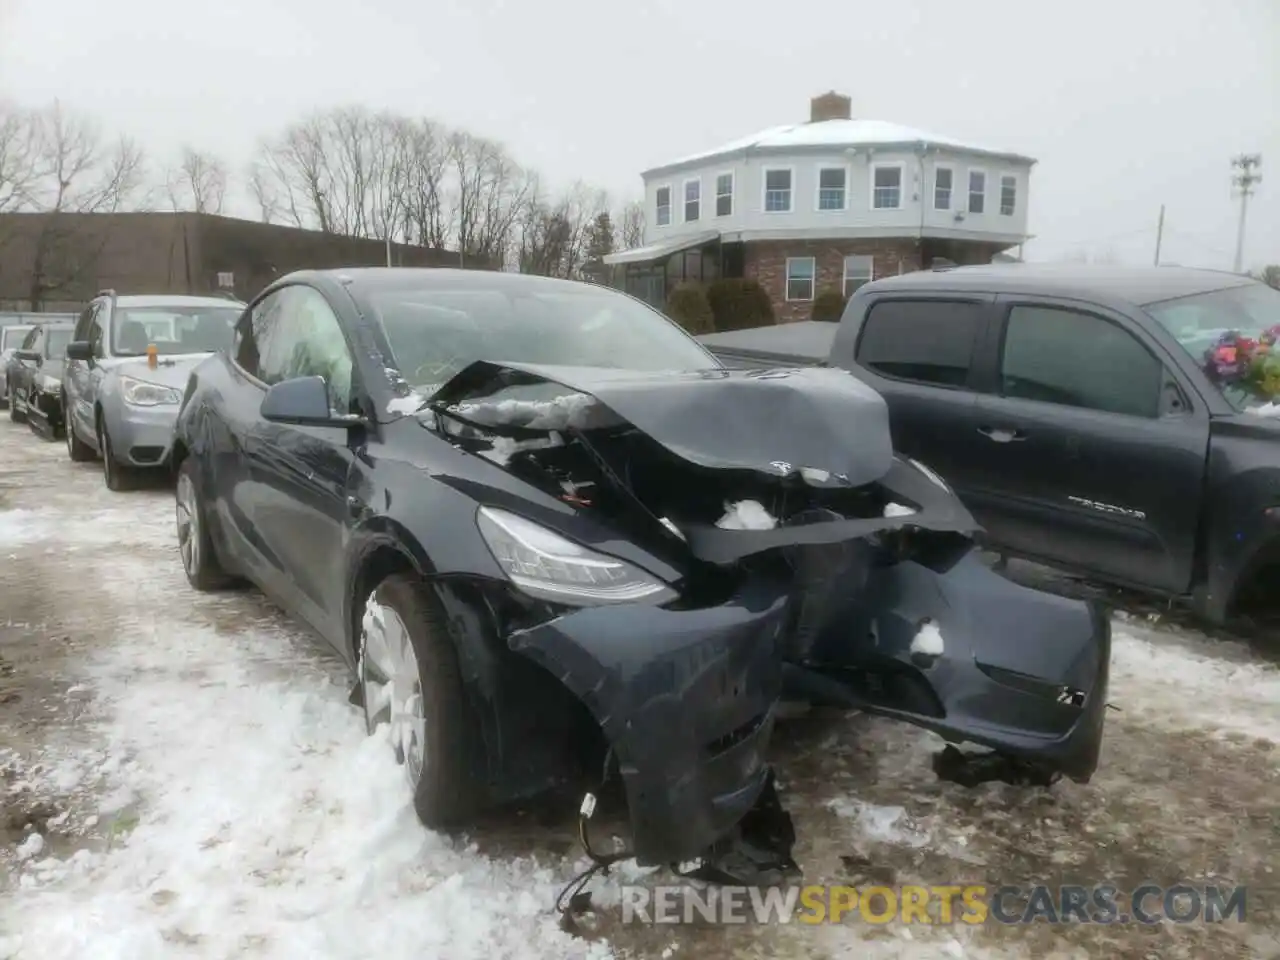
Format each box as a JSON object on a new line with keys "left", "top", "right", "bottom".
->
{"left": 1147, "top": 283, "right": 1280, "bottom": 413}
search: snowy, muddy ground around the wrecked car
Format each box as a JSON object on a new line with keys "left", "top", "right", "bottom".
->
{"left": 0, "top": 424, "right": 1280, "bottom": 960}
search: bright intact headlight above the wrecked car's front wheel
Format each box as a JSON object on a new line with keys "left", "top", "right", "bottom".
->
{"left": 476, "top": 507, "right": 676, "bottom": 607}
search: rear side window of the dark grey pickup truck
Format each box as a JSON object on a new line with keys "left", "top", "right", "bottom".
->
{"left": 856, "top": 300, "right": 983, "bottom": 387}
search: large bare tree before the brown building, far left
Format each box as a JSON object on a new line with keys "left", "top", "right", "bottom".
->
{"left": 23, "top": 101, "right": 146, "bottom": 310}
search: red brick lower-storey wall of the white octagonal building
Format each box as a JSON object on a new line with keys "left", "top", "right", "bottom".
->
{"left": 746, "top": 238, "right": 920, "bottom": 324}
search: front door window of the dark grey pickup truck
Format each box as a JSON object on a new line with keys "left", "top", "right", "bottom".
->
{"left": 1000, "top": 306, "right": 1165, "bottom": 417}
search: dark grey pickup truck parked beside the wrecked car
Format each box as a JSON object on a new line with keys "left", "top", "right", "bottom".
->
{"left": 700, "top": 264, "right": 1280, "bottom": 623}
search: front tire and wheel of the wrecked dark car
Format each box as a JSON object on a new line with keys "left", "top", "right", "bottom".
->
{"left": 357, "top": 573, "right": 480, "bottom": 829}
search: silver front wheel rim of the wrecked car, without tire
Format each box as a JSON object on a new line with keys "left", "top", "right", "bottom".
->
{"left": 360, "top": 609, "right": 426, "bottom": 788}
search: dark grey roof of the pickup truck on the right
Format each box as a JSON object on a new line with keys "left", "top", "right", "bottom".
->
{"left": 859, "top": 262, "right": 1257, "bottom": 306}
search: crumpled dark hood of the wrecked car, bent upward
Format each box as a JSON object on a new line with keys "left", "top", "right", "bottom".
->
{"left": 430, "top": 361, "right": 893, "bottom": 486}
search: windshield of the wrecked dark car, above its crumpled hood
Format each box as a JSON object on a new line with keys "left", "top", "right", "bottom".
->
{"left": 370, "top": 278, "right": 719, "bottom": 394}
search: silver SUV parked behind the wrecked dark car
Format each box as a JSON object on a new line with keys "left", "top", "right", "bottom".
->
{"left": 63, "top": 291, "right": 244, "bottom": 490}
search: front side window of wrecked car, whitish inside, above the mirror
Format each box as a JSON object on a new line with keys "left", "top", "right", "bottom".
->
{"left": 260, "top": 285, "right": 352, "bottom": 413}
